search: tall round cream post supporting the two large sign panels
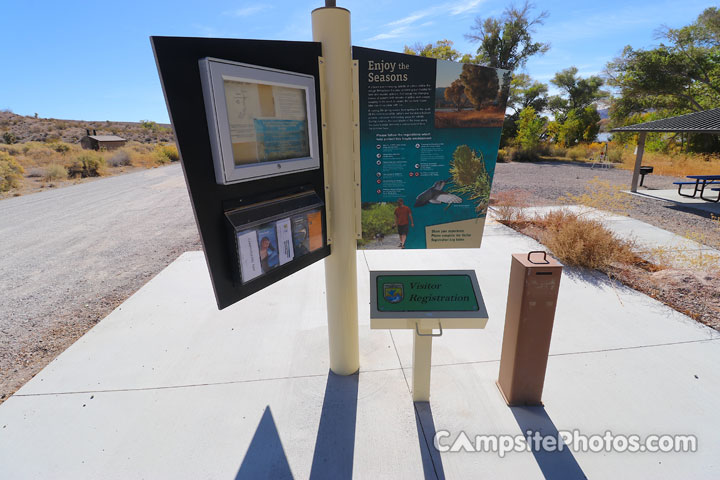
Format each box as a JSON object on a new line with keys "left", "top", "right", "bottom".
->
{"left": 312, "top": 7, "right": 360, "bottom": 375}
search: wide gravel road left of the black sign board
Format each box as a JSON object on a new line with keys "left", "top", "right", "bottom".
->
{"left": 0, "top": 164, "right": 201, "bottom": 402}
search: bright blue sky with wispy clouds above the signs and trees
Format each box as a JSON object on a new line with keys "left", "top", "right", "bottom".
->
{"left": 0, "top": 0, "right": 712, "bottom": 122}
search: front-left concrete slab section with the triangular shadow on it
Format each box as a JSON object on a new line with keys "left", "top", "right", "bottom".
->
{"left": 0, "top": 370, "right": 424, "bottom": 479}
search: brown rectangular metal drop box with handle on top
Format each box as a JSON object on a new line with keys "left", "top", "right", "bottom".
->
{"left": 497, "top": 252, "right": 562, "bottom": 406}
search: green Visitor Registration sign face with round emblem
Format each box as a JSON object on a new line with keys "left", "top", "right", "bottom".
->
{"left": 376, "top": 275, "right": 478, "bottom": 312}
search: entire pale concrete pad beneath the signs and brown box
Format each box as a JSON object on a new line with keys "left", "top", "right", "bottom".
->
{"left": 0, "top": 222, "right": 720, "bottom": 479}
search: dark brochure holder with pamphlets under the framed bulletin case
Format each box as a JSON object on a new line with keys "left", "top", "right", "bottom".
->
{"left": 225, "top": 192, "right": 327, "bottom": 285}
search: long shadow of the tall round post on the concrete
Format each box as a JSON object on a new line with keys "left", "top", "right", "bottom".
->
{"left": 310, "top": 372, "right": 359, "bottom": 480}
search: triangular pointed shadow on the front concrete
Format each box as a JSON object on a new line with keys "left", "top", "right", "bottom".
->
{"left": 235, "top": 405, "right": 293, "bottom": 480}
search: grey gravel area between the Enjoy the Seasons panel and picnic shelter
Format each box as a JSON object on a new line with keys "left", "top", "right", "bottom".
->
{"left": 492, "top": 162, "right": 720, "bottom": 249}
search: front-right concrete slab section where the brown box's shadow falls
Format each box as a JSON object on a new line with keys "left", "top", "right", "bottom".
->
{"left": 422, "top": 340, "right": 720, "bottom": 479}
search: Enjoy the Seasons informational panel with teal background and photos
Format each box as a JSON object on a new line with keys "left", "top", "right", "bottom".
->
{"left": 353, "top": 47, "right": 510, "bottom": 248}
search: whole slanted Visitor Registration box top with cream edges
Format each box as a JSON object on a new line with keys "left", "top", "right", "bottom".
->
{"left": 370, "top": 270, "right": 487, "bottom": 328}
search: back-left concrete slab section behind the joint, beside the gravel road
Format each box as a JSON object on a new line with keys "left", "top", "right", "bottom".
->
{"left": 18, "top": 252, "right": 397, "bottom": 394}
